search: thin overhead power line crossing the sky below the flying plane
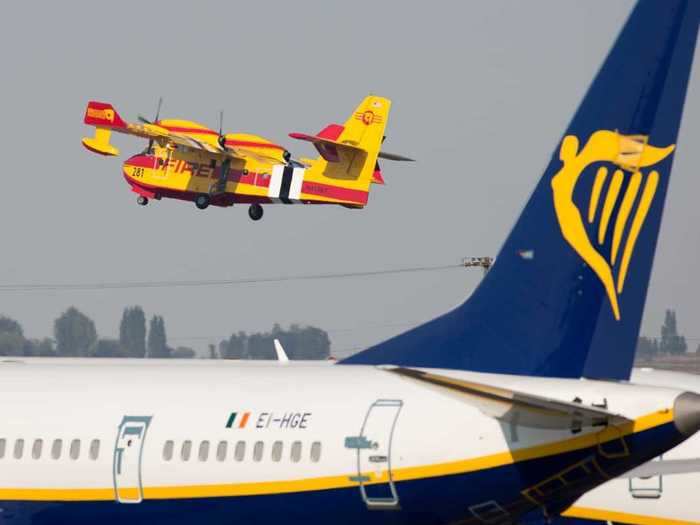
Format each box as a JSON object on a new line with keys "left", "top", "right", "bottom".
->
{"left": 0, "top": 263, "right": 465, "bottom": 292}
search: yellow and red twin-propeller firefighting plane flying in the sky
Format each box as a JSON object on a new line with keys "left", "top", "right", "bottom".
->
{"left": 82, "top": 95, "right": 412, "bottom": 221}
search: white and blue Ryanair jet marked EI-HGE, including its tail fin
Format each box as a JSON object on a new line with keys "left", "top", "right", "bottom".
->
{"left": 0, "top": 0, "right": 700, "bottom": 525}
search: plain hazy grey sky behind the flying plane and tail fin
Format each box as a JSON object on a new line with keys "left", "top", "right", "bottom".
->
{"left": 0, "top": 0, "right": 700, "bottom": 355}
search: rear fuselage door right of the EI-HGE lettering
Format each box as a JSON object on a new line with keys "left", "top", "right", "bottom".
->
{"left": 345, "top": 399, "right": 403, "bottom": 509}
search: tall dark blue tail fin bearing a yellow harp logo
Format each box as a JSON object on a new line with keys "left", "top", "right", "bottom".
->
{"left": 343, "top": 0, "right": 700, "bottom": 379}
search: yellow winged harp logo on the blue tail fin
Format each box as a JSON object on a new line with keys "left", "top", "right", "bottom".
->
{"left": 552, "top": 130, "right": 675, "bottom": 321}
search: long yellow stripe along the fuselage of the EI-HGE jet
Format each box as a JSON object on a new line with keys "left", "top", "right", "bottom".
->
{"left": 0, "top": 409, "right": 673, "bottom": 501}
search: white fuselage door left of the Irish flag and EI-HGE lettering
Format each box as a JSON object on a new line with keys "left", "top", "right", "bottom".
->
{"left": 112, "top": 416, "right": 151, "bottom": 503}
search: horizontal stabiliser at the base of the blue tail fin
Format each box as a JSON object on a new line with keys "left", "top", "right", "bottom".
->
{"left": 386, "top": 367, "right": 631, "bottom": 432}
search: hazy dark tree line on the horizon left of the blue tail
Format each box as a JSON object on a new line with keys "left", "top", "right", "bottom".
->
{"left": 0, "top": 306, "right": 331, "bottom": 359}
